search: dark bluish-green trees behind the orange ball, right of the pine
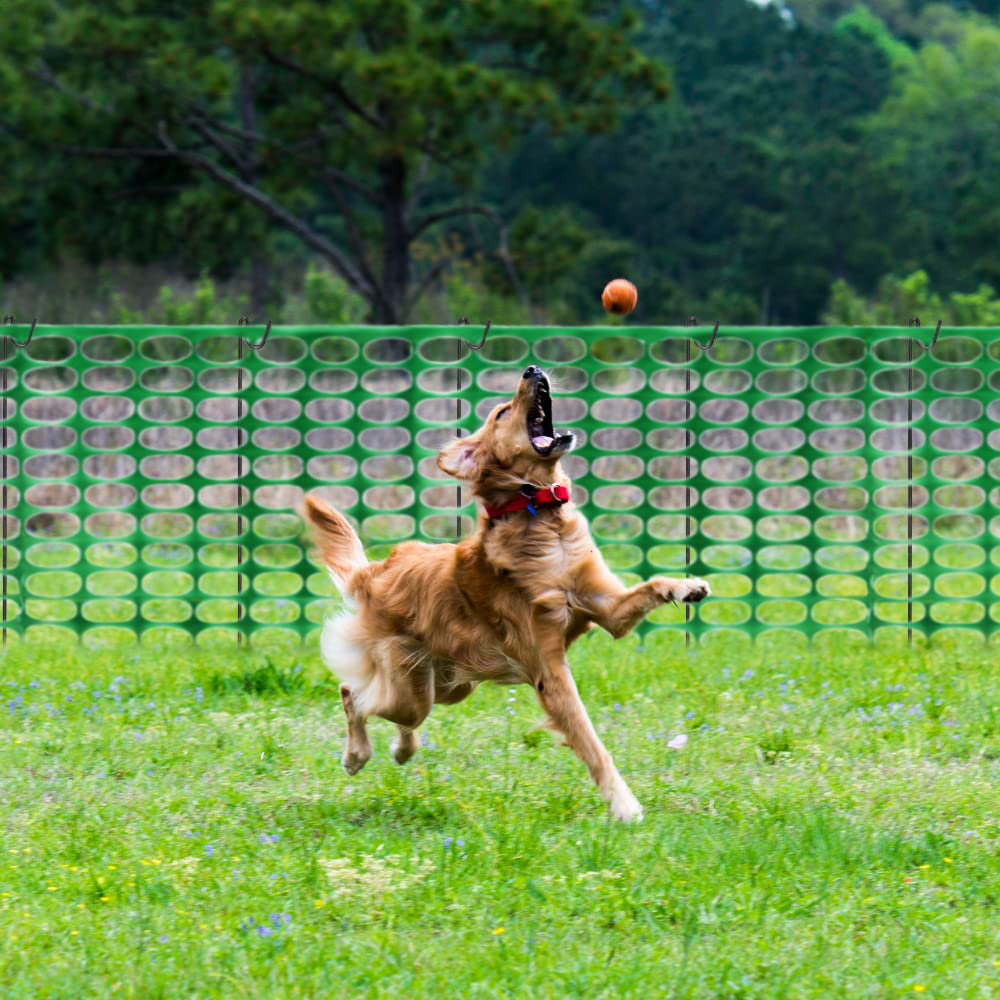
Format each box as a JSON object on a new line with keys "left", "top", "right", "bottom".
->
{"left": 501, "top": 0, "right": 905, "bottom": 324}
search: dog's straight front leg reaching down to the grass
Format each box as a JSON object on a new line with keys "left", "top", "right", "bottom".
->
{"left": 533, "top": 609, "right": 642, "bottom": 822}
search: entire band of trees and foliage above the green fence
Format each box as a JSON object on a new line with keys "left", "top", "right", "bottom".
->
{"left": 0, "top": 0, "right": 1000, "bottom": 324}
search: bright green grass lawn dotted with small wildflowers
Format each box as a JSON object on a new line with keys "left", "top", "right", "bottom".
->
{"left": 0, "top": 636, "right": 1000, "bottom": 1000}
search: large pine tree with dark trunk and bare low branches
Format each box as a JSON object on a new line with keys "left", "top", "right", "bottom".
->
{"left": 0, "top": 0, "right": 668, "bottom": 323}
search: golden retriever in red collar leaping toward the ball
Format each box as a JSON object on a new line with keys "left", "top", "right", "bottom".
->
{"left": 304, "top": 365, "right": 709, "bottom": 821}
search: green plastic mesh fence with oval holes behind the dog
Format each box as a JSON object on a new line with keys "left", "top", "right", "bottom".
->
{"left": 0, "top": 327, "right": 1000, "bottom": 641}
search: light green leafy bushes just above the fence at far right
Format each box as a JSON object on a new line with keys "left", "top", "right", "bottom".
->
{"left": 823, "top": 270, "right": 1000, "bottom": 326}
